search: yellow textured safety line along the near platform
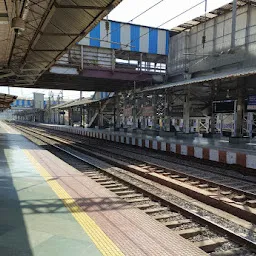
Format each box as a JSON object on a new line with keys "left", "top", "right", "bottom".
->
{"left": 24, "top": 150, "right": 124, "bottom": 256}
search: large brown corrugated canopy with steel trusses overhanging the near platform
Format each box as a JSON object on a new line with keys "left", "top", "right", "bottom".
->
{"left": 0, "top": 0, "right": 122, "bottom": 88}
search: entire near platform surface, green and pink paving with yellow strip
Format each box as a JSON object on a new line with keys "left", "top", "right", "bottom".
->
{"left": 0, "top": 122, "right": 206, "bottom": 256}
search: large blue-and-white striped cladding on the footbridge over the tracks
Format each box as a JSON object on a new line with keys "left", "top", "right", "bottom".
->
{"left": 78, "top": 20, "right": 171, "bottom": 55}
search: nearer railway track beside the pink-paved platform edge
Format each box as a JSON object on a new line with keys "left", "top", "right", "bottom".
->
{"left": 10, "top": 122, "right": 256, "bottom": 256}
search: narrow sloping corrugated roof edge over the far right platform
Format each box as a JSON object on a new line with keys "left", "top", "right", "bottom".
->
{"left": 143, "top": 67, "right": 256, "bottom": 92}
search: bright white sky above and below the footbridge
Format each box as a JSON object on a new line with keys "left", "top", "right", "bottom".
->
{"left": 0, "top": 0, "right": 232, "bottom": 100}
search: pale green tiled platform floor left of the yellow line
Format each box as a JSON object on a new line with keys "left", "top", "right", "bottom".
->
{"left": 0, "top": 123, "right": 101, "bottom": 256}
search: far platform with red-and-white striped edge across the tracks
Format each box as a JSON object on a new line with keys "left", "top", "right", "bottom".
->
{"left": 23, "top": 123, "right": 256, "bottom": 169}
